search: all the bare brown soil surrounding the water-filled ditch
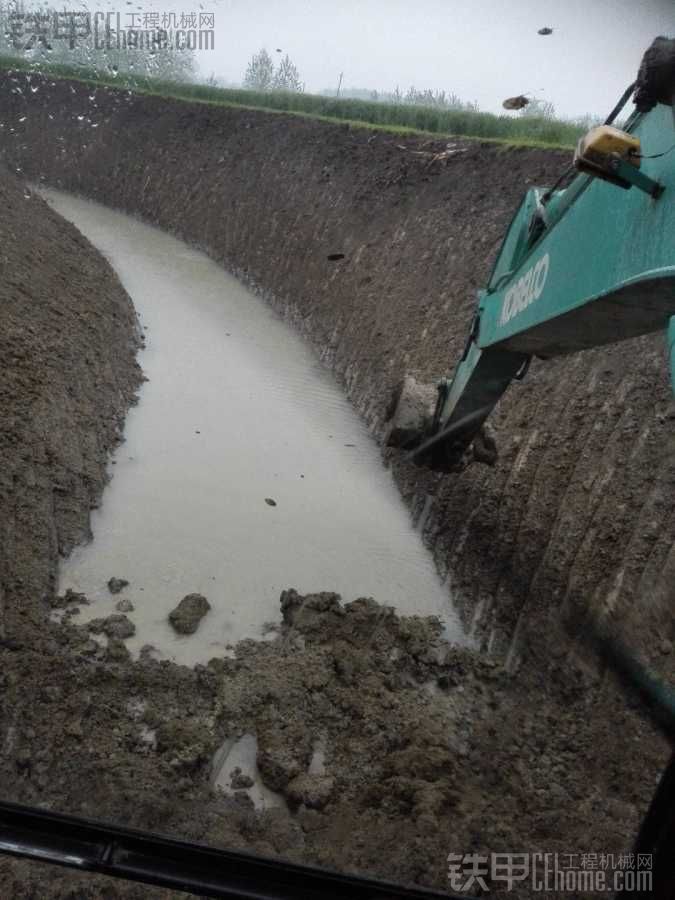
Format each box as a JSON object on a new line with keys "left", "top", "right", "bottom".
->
{"left": 0, "top": 76, "right": 675, "bottom": 898}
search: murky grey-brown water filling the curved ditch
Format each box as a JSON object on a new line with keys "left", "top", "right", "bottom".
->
{"left": 46, "top": 192, "right": 461, "bottom": 664}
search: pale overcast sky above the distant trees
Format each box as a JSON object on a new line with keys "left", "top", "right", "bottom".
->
{"left": 71, "top": 0, "right": 675, "bottom": 116}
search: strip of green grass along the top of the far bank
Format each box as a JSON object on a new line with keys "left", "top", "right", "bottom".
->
{"left": 0, "top": 56, "right": 582, "bottom": 148}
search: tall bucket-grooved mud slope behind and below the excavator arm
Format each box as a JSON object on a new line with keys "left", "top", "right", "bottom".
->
{"left": 0, "top": 75, "right": 675, "bottom": 655}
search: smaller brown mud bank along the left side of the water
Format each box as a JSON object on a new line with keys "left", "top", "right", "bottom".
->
{"left": 0, "top": 170, "right": 141, "bottom": 624}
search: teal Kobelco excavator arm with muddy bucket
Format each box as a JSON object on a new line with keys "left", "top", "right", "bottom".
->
{"left": 387, "top": 37, "right": 675, "bottom": 471}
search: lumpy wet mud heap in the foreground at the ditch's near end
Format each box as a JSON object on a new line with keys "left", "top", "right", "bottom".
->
{"left": 0, "top": 590, "right": 665, "bottom": 900}
